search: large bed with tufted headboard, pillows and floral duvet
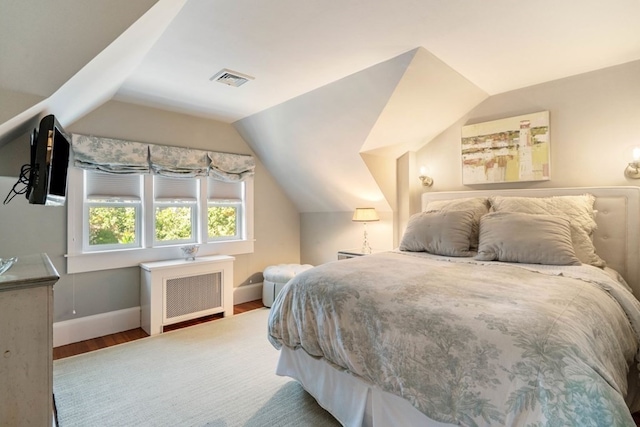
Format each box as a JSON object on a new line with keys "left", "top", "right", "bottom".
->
{"left": 268, "top": 187, "right": 640, "bottom": 426}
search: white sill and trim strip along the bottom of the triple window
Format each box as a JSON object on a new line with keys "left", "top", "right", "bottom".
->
{"left": 66, "top": 240, "right": 253, "bottom": 274}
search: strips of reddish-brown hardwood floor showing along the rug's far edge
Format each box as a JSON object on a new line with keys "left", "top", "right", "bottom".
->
{"left": 53, "top": 300, "right": 264, "bottom": 360}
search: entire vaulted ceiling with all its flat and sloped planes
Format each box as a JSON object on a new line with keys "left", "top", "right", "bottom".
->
{"left": 0, "top": 0, "right": 640, "bottom": 212}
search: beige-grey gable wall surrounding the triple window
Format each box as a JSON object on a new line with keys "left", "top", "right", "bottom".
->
{"left": 0, "top": 101, "right": 300, "bottom": 321}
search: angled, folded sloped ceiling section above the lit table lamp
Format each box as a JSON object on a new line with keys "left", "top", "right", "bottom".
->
{"left": 234, "top": 48, "right": 488, "bottom": 212}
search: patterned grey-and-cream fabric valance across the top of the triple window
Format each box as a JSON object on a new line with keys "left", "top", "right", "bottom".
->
{"left": 71, "top": 134, "right": 255, "bottom": 182}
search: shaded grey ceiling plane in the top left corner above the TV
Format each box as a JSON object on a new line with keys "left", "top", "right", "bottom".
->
{"left": 0, "top": 0, "right": 157, "bottom": 98}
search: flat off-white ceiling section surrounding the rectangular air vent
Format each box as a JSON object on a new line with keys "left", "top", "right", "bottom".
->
{"left": 112, "top": 0, "right": 640, "bottom": 122}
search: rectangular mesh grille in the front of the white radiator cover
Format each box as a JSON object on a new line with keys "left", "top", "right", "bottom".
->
{"left": 166, "top": 272, "right": 222, "bottom": 319}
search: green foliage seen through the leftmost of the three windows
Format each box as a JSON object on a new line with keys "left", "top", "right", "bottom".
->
{"left": 89, "top": 206, "right": 136, "bottom": 245}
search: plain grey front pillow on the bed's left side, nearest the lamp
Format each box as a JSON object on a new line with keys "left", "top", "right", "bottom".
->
{"left": 400, "top": 211, "right": 473, "bottom": 256}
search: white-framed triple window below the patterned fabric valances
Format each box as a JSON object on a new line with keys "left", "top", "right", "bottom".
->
{"left": 67, "top": 167, "right": 253, "bottom": 273}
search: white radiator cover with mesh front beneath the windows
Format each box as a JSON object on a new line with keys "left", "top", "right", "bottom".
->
{"left": 140, "top": 255, "right": 235, "bottom": 335}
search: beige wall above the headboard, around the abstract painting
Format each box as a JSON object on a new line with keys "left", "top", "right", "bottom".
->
{"left": 416, "top": 61, "right": 640, "bottom": 191}
